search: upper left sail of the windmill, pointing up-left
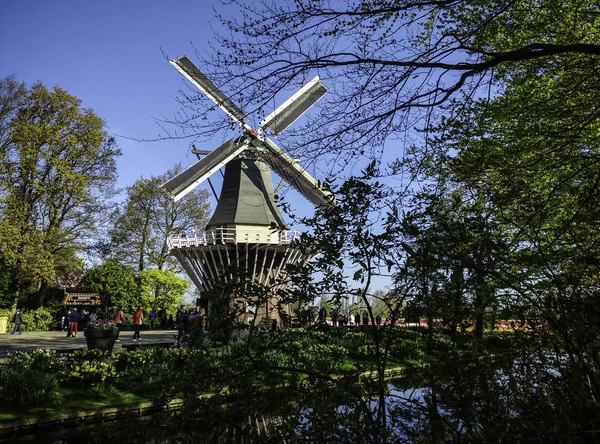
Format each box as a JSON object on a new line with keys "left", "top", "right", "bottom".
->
{"left": 169, "top": 55, "right": 251, "bottom": 130}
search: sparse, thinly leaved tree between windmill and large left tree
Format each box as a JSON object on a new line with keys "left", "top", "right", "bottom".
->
{"left": 110, "top": 164, "right": 210, "bottom": 271}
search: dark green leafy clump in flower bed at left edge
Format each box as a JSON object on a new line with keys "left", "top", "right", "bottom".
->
{"left": 0, "top": 350, "right": 63, "bottom": 404}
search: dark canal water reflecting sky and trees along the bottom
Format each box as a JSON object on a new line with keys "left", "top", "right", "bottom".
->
{"left": 9, "top": 357, "right": 600, "bottom": 444}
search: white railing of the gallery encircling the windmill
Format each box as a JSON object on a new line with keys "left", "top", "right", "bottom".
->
{"left": 167, "top": 228, "right": 301, "bottom": 249}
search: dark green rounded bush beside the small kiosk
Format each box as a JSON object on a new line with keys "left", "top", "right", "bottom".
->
{"left": 79, "top": 260, "right": 141, "bottom": 313}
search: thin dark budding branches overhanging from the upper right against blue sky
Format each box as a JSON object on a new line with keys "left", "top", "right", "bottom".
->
{"left": 164, "top": 0, "right": 600, "bottom": 165}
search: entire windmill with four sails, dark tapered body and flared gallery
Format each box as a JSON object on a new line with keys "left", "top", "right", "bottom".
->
{"left": 161, "top": 56, "right": 332, "bottom": 321}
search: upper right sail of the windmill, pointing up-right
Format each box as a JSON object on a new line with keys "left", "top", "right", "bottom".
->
{"left": 260, "top": 76, "right": 327, "bottom": 134}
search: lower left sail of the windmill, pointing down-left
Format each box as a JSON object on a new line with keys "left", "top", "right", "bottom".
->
{"left": 161, "top": 139, "right": 248, "bottom": 202}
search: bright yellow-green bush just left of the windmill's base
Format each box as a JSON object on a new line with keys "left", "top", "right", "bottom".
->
{"left": 138, "top": 269, "right": 189, "bottom": 312}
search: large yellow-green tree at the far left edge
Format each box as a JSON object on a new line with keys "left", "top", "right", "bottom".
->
{"left": 0, "top": 83, "right": 120, "bottom": 306}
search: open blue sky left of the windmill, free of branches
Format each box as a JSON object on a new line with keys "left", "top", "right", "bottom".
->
{"left": 0, "top": 0, "right": 392, "bottom": 294}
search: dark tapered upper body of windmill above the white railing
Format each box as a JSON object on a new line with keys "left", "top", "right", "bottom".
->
{"left": 208, "top": 157, "right": 285, "bottom": 227}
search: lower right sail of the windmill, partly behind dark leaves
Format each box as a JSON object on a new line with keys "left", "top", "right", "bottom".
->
{"left": 261, "top": 139, "right": 333, "bottom": 207}
